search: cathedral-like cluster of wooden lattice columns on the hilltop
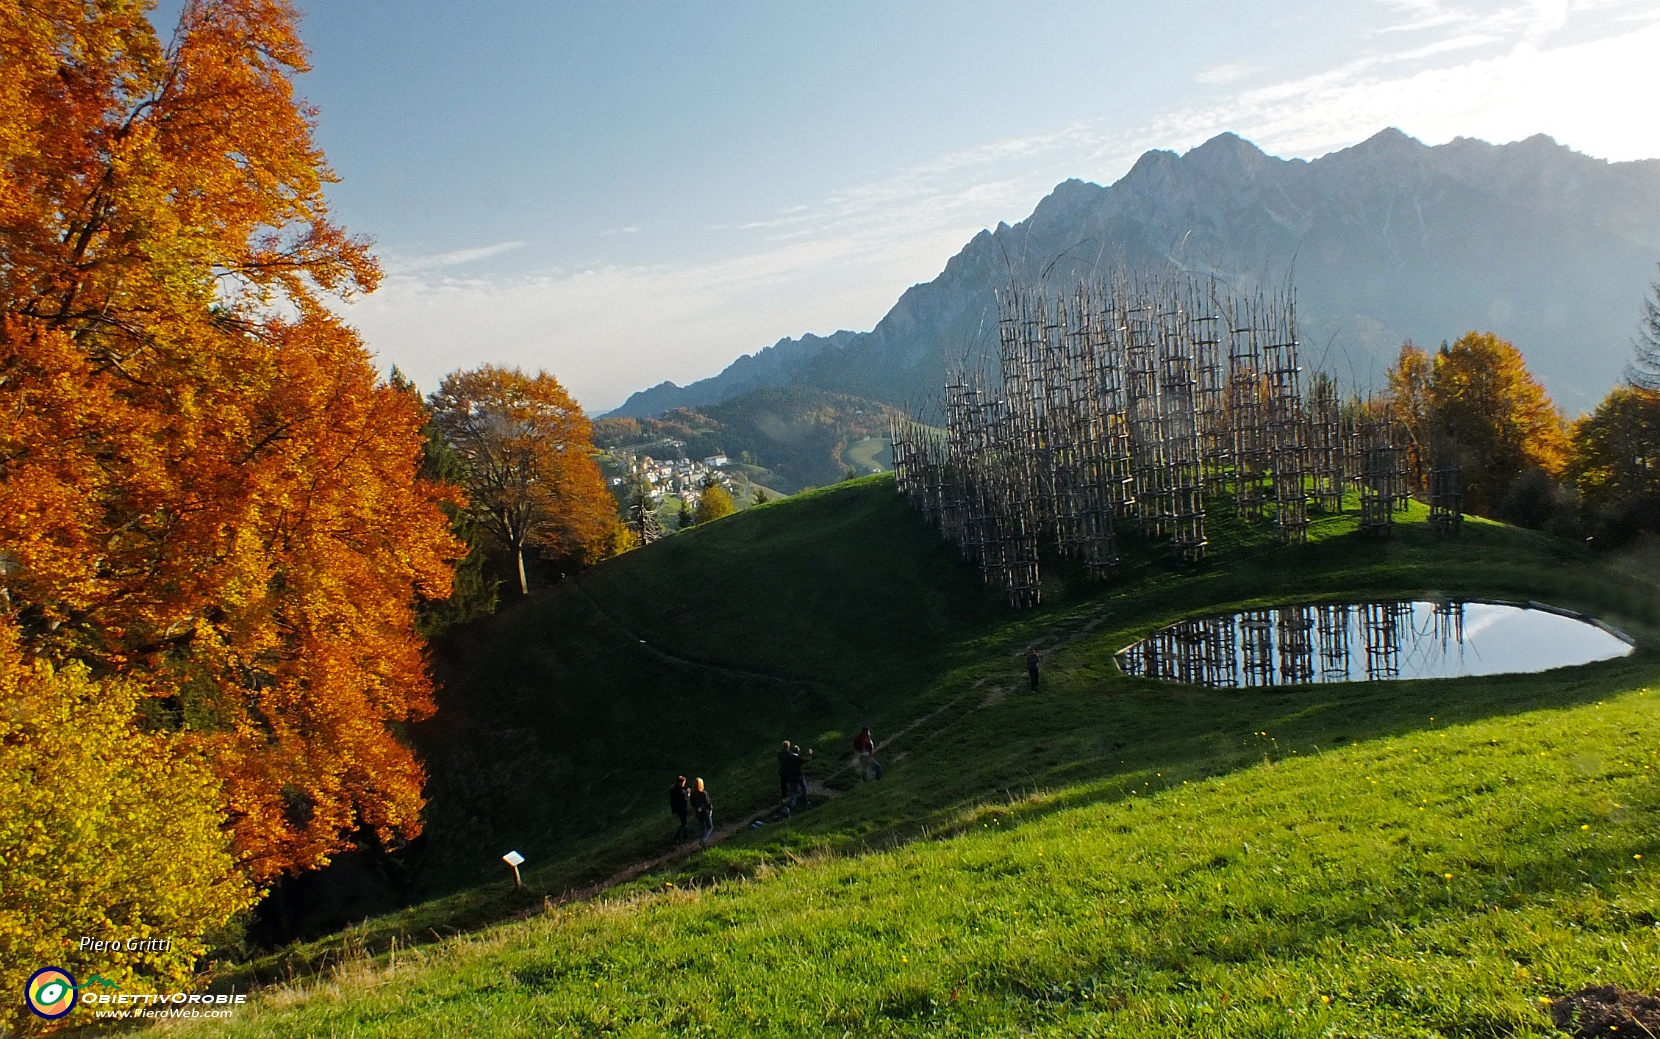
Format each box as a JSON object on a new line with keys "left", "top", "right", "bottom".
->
{"left": 893, "top": 272, "right": 1381, "bottom": 607}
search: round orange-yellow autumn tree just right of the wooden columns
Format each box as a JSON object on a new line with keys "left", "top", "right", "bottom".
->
{"left": 1389, "top": 332, "right": 1569, "bottom": 516}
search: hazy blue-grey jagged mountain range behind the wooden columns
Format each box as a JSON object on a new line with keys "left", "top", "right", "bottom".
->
{"left": 618, "top": 129, "right": 1660, "bottom": 415}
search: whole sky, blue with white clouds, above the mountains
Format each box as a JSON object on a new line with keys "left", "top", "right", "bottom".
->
{"left": 230, "top": 0, "right": 1660, "bottom": 413}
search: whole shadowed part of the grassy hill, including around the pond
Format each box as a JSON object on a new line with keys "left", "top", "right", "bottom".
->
{"left": 230, "top": 480, "right": 1660, "bottom": 978}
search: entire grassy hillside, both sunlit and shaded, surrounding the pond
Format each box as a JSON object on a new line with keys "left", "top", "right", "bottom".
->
{"left": 207, "top": 478, "right": 1660, "bottom": 1034}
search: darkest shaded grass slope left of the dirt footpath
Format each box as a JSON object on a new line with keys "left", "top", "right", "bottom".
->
{"left": 250, "top": 480, "right": 1009, "bottom": 942}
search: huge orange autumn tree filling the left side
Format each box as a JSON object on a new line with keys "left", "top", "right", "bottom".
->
{"left": 0, "top": 0, "right": 461, "bottom": 916}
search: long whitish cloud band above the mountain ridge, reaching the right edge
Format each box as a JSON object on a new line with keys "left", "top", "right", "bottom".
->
{"left": 350, "top": 0, "right": 1660, "bottom": 410}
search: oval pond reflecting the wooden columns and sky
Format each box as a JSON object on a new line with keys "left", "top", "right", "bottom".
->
{"left": 1117, "top": 599, "right": 1633, "bottom": 687}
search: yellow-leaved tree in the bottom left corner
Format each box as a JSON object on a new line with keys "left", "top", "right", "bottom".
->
{"left": 0, "top": 624, "right": 254, "bottom": 1031}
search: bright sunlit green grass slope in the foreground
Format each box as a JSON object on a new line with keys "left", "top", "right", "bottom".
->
{"left": 181, "top": 666, "right": 1660, "bottom": 1036}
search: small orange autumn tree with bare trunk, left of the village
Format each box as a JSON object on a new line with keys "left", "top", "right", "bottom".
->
{"left": 430, "top": 365, "right": 621, "bottom": 594}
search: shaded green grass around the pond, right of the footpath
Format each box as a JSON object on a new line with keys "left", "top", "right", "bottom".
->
{"left": 717, "top": 543, "right": 1660, "bottom": 876}
